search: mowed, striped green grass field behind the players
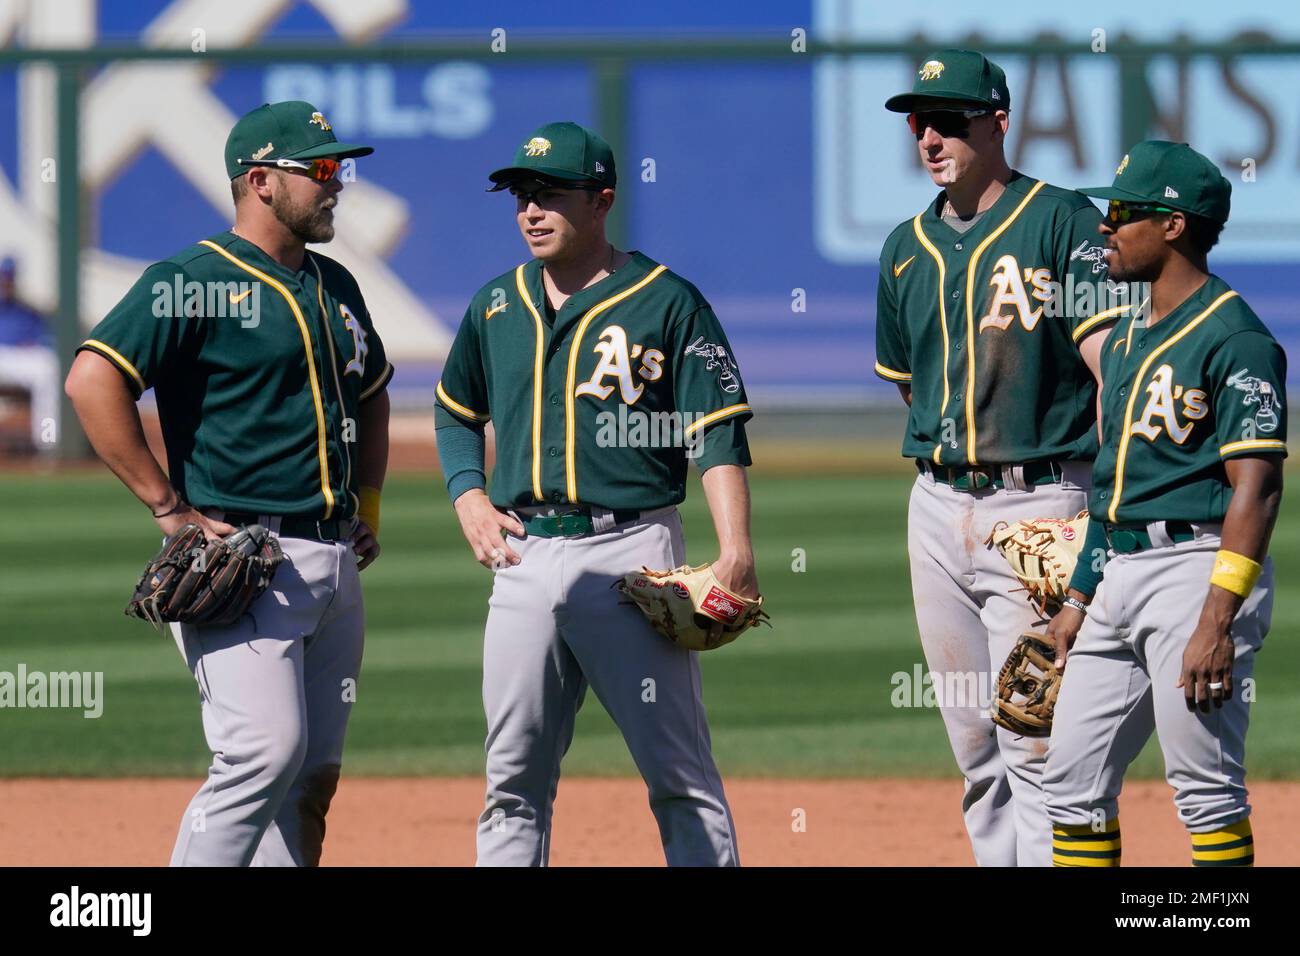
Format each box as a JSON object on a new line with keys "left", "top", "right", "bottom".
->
{"left": 0, "top": 475, "right": 1300, "bottom": 779}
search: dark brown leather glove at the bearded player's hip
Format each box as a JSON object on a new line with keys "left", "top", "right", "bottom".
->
{"left": 126, "top": 524, "right": 285, "bottom": 628}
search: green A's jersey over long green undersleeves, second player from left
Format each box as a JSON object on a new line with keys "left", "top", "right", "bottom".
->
{"left": 437, "top": 252, "right": 751, "bottom": 509}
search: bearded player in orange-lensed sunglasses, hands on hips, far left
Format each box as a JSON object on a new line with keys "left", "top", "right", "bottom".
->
{"left": 66, "top": 101, "right": 393, "bottom": 866}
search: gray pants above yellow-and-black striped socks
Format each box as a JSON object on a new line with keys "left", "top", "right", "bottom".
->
{"left": 1043, "top": 538, "right": 1273, "bottom": 832}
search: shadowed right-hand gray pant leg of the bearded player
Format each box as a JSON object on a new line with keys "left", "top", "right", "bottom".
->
{"left": 252, "top": 544, "right": 365, "bottom": 866}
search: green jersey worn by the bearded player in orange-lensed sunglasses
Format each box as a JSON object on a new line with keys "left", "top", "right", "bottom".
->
{"left": 78, "top": 232, "right": 393, "bottom": 519}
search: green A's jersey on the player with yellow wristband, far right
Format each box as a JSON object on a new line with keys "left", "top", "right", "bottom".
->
{"left": 1088, "top": 276, "right": 1287, "bottom": 524}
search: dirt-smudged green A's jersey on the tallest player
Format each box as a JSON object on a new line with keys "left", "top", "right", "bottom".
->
{"left": 876, "top": 173, "right": 1119, "bottom": 466}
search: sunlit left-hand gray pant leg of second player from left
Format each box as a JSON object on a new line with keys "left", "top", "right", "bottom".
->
{"left": 477, "top": 537, "right": 586, "bottom": 866}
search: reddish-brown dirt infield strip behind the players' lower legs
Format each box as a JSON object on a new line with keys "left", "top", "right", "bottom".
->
{"left": 0, "top": 777, "right": 1300, "bottom": 866}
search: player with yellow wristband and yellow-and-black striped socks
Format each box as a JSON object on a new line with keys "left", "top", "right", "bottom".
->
{"left": 1044, "top": 140, "right": 1287, "bottom": 866}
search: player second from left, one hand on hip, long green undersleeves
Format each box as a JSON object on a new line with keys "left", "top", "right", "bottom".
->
{"left": 437, "top": 122, "right": 758, "bottom": 866}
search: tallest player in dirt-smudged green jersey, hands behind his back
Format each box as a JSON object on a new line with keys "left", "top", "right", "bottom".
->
{"left": 876, "top": 49, "right": 1114, "bottom": 866}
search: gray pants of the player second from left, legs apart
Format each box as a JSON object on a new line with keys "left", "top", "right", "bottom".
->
{"left": 478, "top": 509, "right": 740, "bottom": 866}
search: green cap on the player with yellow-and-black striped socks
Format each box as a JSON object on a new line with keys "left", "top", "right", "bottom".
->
{"left": 1079, "top": 139, "right": 1232, "bottom": 225}
